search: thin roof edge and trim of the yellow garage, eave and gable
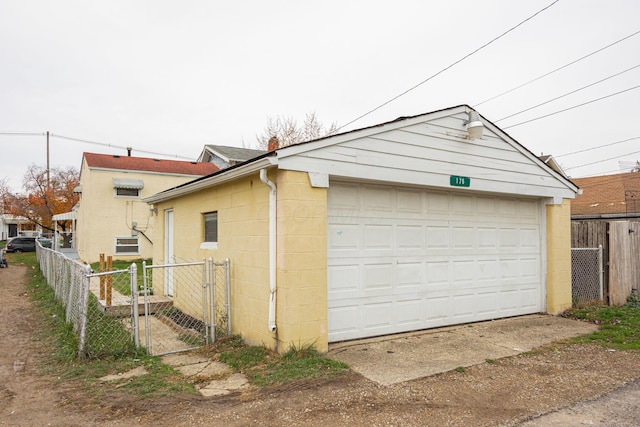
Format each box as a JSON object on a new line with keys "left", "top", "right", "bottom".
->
{"left": 148, "top": 104, "right": 578, "bottom": 203}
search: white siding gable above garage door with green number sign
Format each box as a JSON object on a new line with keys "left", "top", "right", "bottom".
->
{"left": 278, "top": 106, "right": 575, "bottom": 198}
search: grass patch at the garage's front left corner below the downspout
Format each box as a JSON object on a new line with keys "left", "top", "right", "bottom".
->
{"left": 203, "top": 335, "right": 349, "bottom": 388}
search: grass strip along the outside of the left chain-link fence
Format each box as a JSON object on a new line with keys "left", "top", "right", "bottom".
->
{"left": 15, "top": 252, "right": 196, "bottom": 399}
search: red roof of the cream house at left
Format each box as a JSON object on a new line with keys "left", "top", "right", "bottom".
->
{"left": 83, "top": 153, "right": 219, "bottom": 176}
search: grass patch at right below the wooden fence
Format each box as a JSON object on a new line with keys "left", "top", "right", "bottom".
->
{"left": 564, "top": 304, "right": 640, "bottom": 350}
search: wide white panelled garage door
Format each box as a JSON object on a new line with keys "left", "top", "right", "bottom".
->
{"left": 327, "top": 182, "right": 544, "bottom": 342}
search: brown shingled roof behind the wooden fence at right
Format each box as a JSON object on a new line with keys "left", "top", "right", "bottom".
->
{"left": 571, "top": 172, "right": 640, "bottom": 218}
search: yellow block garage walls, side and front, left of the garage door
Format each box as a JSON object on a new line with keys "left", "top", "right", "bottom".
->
{"left": 153, "top": 170, "right": 328, "bottom": 351}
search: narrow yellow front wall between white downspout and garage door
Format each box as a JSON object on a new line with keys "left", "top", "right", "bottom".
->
{"left": 277, "top": 171, "right": 328, "bottom": 351}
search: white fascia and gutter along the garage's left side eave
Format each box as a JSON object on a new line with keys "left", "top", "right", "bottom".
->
{"left": 142, "top": 156, "right": 278, "bottom": 204}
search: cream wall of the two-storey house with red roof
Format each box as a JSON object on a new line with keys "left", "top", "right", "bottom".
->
{"left": 76, "top": 160, "right": 204, "bottom": 263}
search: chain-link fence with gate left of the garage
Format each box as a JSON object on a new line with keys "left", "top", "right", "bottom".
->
{"left": 36, "top": 246, "right": 231, "bottom": 358}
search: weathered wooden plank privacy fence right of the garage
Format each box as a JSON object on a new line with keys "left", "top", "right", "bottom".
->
{"left": 571, "top": 220, "right": 640, "bottom": 305}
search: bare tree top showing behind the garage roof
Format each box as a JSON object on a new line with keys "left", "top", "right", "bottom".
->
{"left": 256, "top": 112, "right": 338, "bottom": 150}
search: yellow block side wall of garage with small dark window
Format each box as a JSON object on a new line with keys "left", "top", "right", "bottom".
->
{"left": 153, "top": 173, "right": 275, "bottom": 348}
